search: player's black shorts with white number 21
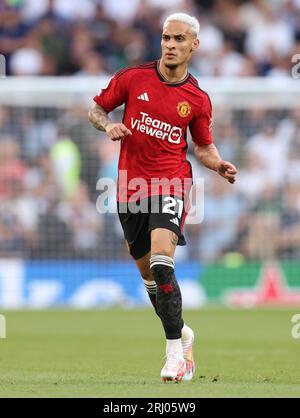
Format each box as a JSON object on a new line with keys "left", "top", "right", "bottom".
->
{"left": 118, "top": 196, "right": 186, "bottom": 260}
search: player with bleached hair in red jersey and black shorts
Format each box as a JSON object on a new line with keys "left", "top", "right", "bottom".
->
{"left": 89, "top": 13, "right": 237, "bottom": 382}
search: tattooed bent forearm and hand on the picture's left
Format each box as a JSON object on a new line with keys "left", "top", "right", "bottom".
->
{"left": 89, "top": 103, "right": 132, "bottom": 141}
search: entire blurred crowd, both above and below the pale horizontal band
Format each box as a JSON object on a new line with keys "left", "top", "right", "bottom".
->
{"left": 0, "top": 0, "right": 300, "bottom": 262}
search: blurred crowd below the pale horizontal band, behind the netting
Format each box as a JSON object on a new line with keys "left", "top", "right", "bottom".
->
{"left": 0, "top": 103, "right": 300, "bottom": 262}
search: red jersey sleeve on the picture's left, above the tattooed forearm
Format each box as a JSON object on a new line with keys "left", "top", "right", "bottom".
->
{"left": 94, "top": 72, "right": 128, "bottom": 113}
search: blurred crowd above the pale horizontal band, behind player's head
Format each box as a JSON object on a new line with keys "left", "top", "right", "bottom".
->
{"left": 0, "top": 0, "right": 300, "bottom": 77}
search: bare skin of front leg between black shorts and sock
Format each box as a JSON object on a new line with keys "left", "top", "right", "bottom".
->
{"left": 151, "top": 228, "right": 178, "bottom": 258}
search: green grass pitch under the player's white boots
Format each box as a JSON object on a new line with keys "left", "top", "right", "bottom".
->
{"left": 0, "top": 308, "right": 300, "bottom": 398}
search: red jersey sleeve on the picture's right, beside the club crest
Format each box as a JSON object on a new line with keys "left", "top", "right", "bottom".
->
{"left": 189, "top": 94, "right": 213, "bottom": 145}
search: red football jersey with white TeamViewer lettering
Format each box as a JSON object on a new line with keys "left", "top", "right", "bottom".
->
{"left": 94, "top": 61, "right": 212, "bottom": 202}
